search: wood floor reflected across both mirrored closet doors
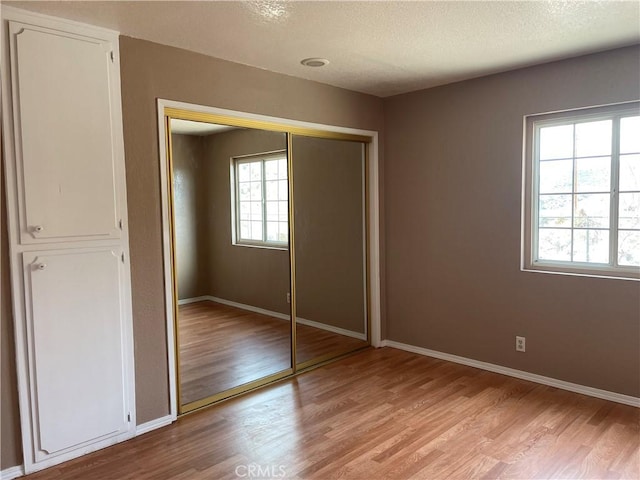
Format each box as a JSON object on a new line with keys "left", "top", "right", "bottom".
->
{"left": 178, "top": 301, "right": 366, "bottom": 404}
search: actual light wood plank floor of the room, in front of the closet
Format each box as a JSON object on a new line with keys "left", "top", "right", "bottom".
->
{"left": 22, "top": 348, "right": 640, "bottom": 480}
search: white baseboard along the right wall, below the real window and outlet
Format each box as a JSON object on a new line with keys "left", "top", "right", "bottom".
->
{"left": 381, "top": 340, "right": 640, "bottom": 407}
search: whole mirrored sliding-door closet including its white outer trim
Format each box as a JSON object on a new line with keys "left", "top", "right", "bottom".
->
{"left": 158, "top": 100, "right": 379, "bottom": 414}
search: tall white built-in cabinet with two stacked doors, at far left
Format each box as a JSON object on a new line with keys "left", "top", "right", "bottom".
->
{"left": 0, "top": 7, "right": 135, "bottom": 473}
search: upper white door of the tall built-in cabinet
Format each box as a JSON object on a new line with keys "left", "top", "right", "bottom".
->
{"left": 10, "top": 22, "right": 119, "bottom": 243}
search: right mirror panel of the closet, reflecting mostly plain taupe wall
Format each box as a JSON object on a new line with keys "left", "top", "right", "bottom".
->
{"left": 292, "top": 135, "right": 368, "bottom": 365}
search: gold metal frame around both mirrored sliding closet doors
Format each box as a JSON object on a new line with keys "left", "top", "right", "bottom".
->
{"left": 159, "top": 106, "right": 373, "bottom": 415}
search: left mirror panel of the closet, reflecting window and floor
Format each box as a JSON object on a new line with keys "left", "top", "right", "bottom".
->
{"left": 171, "top": 119, "right": 291, "bottom": 411}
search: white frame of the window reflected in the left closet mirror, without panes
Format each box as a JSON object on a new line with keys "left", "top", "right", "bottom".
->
{"left": 230, "top": 149, "right": 290, "bottom": 250}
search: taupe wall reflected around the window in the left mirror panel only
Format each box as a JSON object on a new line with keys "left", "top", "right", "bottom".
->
{"left": 172, "top": 129, "right": 289, "bottom": 314}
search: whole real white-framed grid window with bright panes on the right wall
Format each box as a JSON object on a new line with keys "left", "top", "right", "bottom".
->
{"left": 524, "top": 102, "right": 640, "bottom": 278}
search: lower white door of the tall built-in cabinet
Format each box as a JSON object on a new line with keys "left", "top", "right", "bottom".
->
{"left": 23, "top": 247, "right": 130, "bottom": 461}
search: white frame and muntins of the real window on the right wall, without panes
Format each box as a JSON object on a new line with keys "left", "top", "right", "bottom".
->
{"left": 521, "top": 101, "right": 640, "bottom": 280}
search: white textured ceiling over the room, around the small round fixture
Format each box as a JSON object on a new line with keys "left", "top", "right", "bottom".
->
{"left": 2, "top": 0, "right": 640, "bottom": 97}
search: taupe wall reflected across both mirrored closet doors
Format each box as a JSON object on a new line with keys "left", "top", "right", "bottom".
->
{"left": 172, "top": 129, "right": 365, "bottom": 332}
